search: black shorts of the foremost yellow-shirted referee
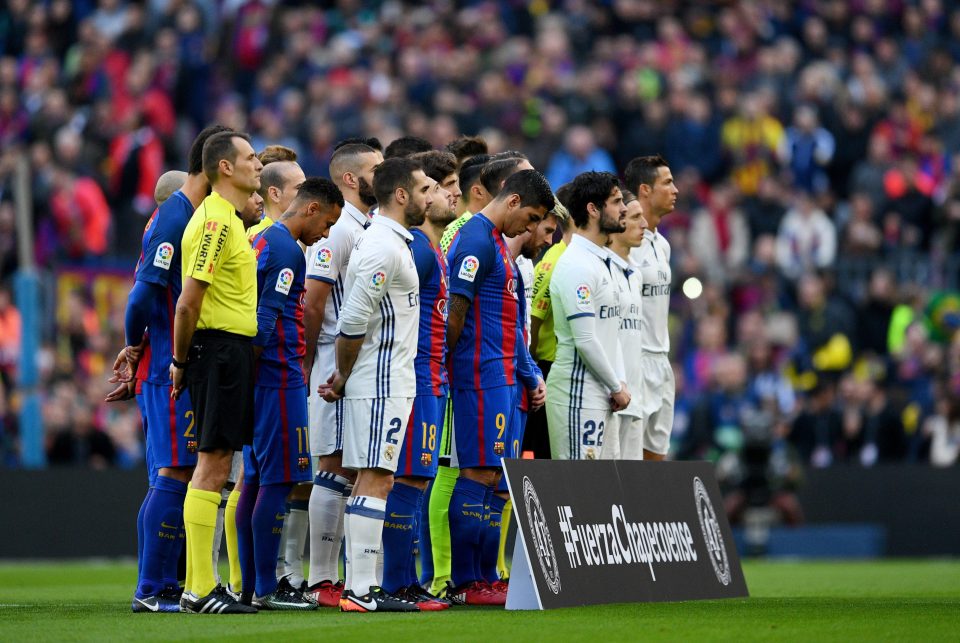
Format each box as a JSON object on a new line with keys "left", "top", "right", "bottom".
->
{"left": 185, "top": 330, "right": 254, "bottom": 452}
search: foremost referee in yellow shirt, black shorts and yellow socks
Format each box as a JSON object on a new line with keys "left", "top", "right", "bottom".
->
{"left": 170, "top": 132, "right": 263, "bottom": 614}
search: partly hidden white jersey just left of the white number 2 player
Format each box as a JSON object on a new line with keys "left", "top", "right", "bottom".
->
{"left": 306, "top": 202, "right": 370, "bottom": 344}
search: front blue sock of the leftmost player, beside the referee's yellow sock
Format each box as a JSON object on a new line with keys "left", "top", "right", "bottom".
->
{"left": 137, "top": 476, "right": 187, "bottom": 598}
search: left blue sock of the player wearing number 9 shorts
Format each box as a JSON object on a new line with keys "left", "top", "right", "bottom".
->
{"left": 450, "top": 477, "right": 487, "bottom": 585}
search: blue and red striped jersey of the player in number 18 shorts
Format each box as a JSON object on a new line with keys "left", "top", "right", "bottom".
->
{"left": 410, "top": 229, "right": 449, "bottom": 396}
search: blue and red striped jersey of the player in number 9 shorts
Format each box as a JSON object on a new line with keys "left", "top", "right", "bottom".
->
{"left": 447, "top": 213, "right": 523, "bottom": 390}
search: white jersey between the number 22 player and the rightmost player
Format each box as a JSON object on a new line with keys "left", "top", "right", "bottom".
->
{"left": 610, "top": 252, "right": 643, "bottom": 417}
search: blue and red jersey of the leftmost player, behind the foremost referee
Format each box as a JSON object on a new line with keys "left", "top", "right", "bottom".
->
{"left": 134, "top": 190, "right": 194, "bottom": 385}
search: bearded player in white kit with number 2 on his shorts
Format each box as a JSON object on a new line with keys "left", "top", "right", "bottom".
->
{"left": 318, "top": 158, "right": 435, "bottom": 612}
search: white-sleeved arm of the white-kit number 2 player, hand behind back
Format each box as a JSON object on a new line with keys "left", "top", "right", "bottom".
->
{"left": 318, "top": 245, "right": 398, "bottom": 402}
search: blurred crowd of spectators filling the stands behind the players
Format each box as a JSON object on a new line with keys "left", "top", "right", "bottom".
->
{"left": 0, "top": 0, "right": 960, "bottom": 489}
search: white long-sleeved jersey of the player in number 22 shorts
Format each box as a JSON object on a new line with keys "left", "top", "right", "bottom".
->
{"left": 547, "top": 234, "right": 622, "bottom": 409}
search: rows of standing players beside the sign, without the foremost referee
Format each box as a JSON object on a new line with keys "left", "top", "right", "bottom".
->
{"left": 113, "top": 127, "right": 676, "bottom": 613}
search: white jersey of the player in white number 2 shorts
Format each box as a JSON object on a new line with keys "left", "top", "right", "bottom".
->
{"left": 338, "top": 215, "right": 420, "bottom": 398}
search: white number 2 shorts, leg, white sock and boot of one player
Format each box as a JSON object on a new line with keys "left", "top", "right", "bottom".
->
{"left": 340, "top": 398, "right": 419, "bottom": 612}
